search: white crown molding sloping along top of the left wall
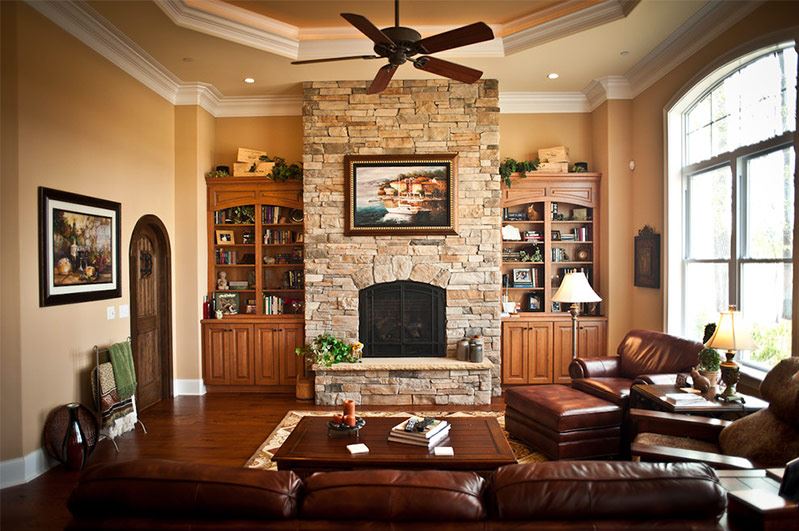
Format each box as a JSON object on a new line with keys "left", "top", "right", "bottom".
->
{"left": 26, "top": 0, "right": 180, "bottom": 103}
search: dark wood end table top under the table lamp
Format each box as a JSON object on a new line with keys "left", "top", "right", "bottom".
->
{"left": 630, "top": 384, "right": 768, "bottom": 420}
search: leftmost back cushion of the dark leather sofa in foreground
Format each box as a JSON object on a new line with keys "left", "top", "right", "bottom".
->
{"left": 68, "top": 459, "right": 302, "bottom": 520}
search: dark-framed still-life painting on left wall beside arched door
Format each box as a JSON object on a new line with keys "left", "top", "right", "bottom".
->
{"left": 39, "top": 187, "right": 122, "bottom": 306}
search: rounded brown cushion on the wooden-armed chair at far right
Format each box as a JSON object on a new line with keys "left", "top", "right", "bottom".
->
{"left": 719, "top": 408, "right": 799, "bottom": 468}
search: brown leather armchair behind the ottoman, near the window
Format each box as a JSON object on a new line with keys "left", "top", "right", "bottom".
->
{"left": 569, "top": 330, "right": 703, "bottom": 407}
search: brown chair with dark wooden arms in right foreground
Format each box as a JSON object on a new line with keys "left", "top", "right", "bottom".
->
{"left": 630, "top": 357, "right": 799, "bottom": 468}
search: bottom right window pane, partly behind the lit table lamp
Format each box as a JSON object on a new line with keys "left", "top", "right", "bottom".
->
{"left": 741, "top": 263, "right": 793, "bottom": 368}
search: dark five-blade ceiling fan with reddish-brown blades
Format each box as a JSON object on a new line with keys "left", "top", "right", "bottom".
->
{"left": 291, "top": 0, "right": 494, "bottom": 94}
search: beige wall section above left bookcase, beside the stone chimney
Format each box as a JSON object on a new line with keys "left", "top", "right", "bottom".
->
{"left": 214, "top": 116, "right": 302, "bottom": 170}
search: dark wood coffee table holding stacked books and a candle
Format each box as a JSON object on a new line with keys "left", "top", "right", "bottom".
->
{"left": 272, "top": 416, "right": 516, "bottom": 476}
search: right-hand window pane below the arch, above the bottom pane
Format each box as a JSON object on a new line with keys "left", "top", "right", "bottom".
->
{"left": 744, "top": 148, "right": 794, "bottom": 258}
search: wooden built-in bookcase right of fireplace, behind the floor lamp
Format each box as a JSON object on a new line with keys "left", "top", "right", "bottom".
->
{"left": 501, "top": 173, "right": 607, "bottom": 384}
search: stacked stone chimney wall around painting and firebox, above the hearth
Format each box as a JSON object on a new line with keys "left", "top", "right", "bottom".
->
{"left": 303, "top": 80, "right": 501, "bottom": 404}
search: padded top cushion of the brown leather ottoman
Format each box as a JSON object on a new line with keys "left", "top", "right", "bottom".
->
{"left": 505, "top": 385, "right": 622, "bottom": 432}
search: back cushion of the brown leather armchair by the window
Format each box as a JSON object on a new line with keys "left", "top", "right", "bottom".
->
{"left": 617, "top": 330, "right": 703, "bottom": 378}
